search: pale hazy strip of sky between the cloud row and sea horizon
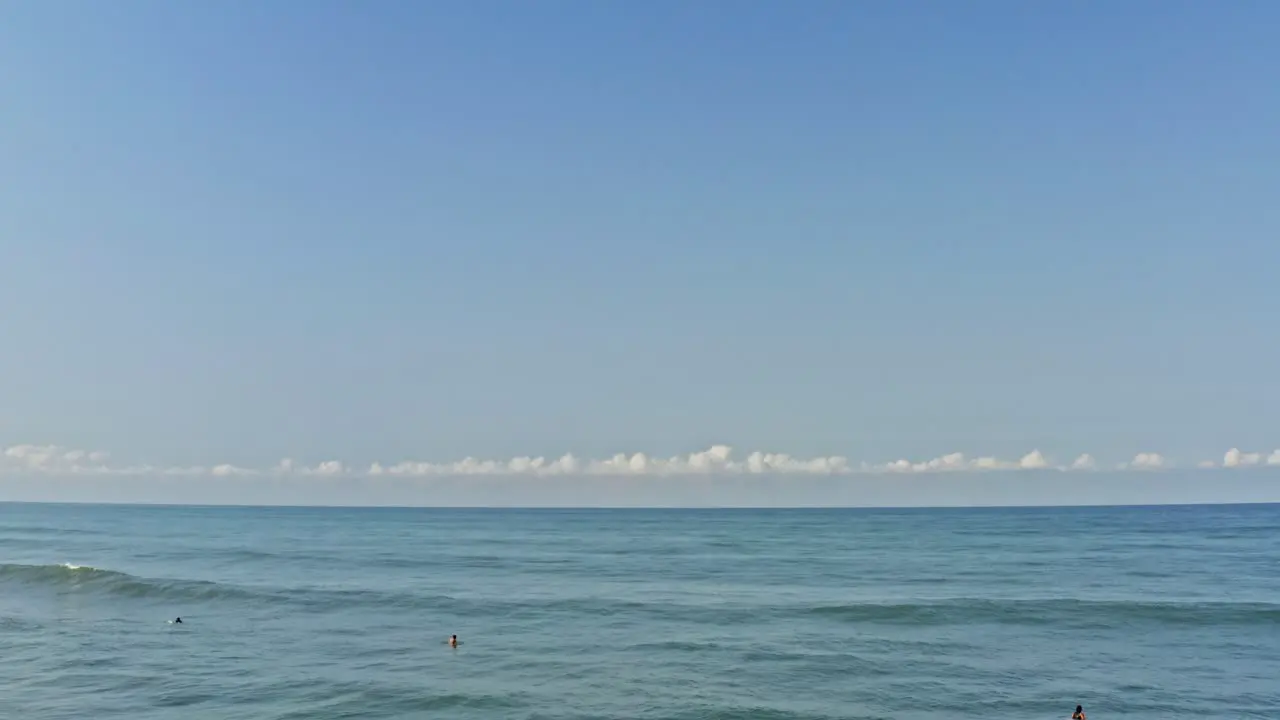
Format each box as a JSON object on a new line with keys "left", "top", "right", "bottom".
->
{"left": 0, "top": 468, "right": 1280, "bottom": 511}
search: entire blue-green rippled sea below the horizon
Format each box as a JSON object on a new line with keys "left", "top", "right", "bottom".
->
{"left": 0, "top": 505, "right": 1280, "bottom": 720}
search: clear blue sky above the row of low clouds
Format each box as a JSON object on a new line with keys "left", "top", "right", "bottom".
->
{"left": 0, "top": 0, "right": 1280, "bottom": 497}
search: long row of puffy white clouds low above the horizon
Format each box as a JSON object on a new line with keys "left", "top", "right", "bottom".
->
{"left": 0, "top": 445, "right": 1280, "bottom": 478}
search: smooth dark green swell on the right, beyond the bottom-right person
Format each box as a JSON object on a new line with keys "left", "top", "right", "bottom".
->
{"left": 808, "top": 598, "right": 1280, "bottom": 626}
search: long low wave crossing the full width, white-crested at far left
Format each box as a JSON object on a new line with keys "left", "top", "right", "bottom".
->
{"left": 0, "top": 562, "right": 1280, "bottom": 627}
